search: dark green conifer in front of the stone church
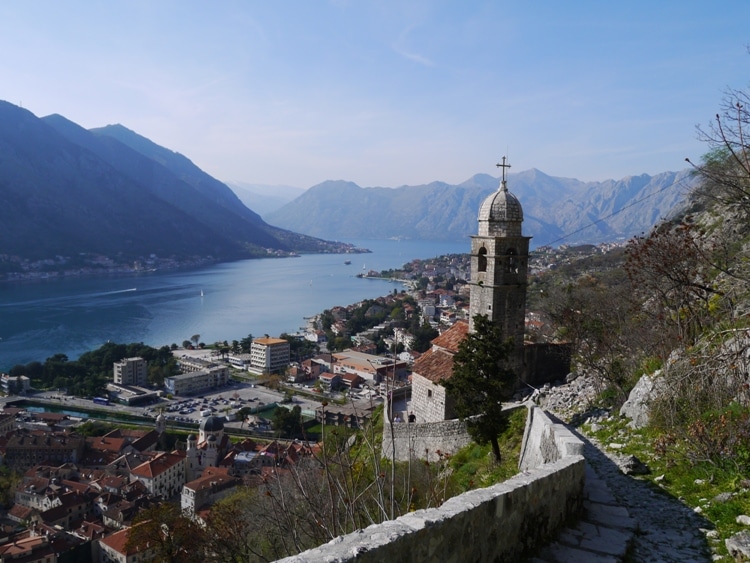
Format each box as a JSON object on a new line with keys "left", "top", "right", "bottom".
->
{"left": 443, "top": 315, "right": 518, "bottom": 462}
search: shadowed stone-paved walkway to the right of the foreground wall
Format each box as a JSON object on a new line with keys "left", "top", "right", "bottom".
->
{"left": 531, "top": 430, "right": 712, "bottom": 563}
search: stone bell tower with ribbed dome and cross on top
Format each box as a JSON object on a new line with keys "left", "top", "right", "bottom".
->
{"left": 469, "top": 157, "right": 531, "bottom": 376}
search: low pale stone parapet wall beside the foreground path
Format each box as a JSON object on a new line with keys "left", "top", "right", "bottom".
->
{"left": 282, "top": 406, "right": 585, "bottom": 563}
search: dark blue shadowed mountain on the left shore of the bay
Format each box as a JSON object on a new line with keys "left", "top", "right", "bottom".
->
{"left": 0, "top": 101, "right": 352, "bottom": 280}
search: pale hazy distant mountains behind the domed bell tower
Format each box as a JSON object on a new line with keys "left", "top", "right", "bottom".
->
{"left": 268, "top": 169, "right": 691, "bottom": 246}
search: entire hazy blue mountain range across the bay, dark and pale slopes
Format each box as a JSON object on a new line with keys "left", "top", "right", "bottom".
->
{"left": 0, "top": 101, "right": 692, "bottom": 277}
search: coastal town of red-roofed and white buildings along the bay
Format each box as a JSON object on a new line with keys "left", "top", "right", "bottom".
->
{"left": 0, "top": 241, "right": 624, "bottom": 562}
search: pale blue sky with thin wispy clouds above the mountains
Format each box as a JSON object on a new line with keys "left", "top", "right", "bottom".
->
{"left": 0, "top": 0, "right": 750, "bottom": 188}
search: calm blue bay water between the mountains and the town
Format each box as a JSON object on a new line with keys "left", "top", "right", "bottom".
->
{"left": 0, "top": 238, "right": 470, "bottom": 371}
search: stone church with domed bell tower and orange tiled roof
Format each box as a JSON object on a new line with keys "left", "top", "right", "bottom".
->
{"left": 411, "top": 157, "right": 567, "bottom": 423}
